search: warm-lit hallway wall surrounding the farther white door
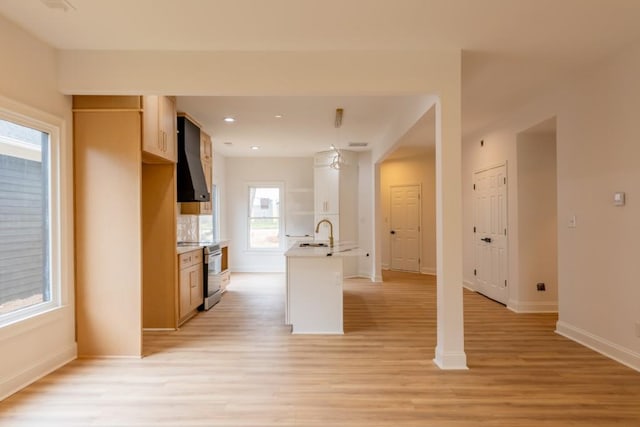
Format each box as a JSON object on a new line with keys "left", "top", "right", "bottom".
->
{"left": 380, "top": 151, "right": 436, "bottom": 274}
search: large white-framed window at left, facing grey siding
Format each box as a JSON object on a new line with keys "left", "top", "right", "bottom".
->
{"left": 0, "top": 111, "right": 59, "bottom": 325}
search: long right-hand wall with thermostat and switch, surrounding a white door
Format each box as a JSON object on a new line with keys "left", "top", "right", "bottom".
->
{"left": 463, "top": 37, "right": 640, "bottom": 370}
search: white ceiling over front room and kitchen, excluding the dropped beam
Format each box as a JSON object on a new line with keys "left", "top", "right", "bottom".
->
{"left": 0, "top": 0, "right": 640, "bottom": 156}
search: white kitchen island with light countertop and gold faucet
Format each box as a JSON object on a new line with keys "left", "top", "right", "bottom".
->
{"left": 285, "top": 242, "right": 365, "bottom": 334}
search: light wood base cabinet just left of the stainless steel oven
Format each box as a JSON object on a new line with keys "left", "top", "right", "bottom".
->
{"left": 178, "top": 249, "right": 204, "bottom": 324}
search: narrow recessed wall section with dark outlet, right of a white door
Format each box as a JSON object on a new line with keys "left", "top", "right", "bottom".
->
{"left": 509, "top": 133, "right": 558, "bottom": 312}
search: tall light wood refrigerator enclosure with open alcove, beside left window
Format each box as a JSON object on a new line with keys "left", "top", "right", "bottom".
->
{"left": 73, "top": 96, "right": 178, "bottom": 357}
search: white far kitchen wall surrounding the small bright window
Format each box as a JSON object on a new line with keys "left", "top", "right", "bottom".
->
{"left": 226, "top": 157, "right": 313, "bottom": 272}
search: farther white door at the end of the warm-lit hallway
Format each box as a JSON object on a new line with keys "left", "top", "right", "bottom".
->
{"left": 390, "top": 185, "right": 422, "bottom": 272}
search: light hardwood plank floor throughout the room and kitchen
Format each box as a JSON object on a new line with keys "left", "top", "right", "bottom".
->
{"left": 0, "top": 273, "right": 640, "bottom": 427}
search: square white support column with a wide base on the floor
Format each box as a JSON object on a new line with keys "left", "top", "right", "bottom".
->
{"left": 434, "top": 90, "right": 467, "bottom": 369}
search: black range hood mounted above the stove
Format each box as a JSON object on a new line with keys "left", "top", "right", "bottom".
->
{"left": 177, "top": 116, "right": 211, "bottom": 202}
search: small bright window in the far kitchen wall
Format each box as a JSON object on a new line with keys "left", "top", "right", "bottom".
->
{"left": 249, "top": 184, "right": 282, "bottom": 250}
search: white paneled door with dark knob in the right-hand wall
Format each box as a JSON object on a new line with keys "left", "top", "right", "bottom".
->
{"left": 473, "top": 165, "right": 508, "bottom": 304}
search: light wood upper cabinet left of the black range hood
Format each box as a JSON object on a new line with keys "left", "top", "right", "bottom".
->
{"left": 142, "top": 96, "right": 177, "bottom": 163}
